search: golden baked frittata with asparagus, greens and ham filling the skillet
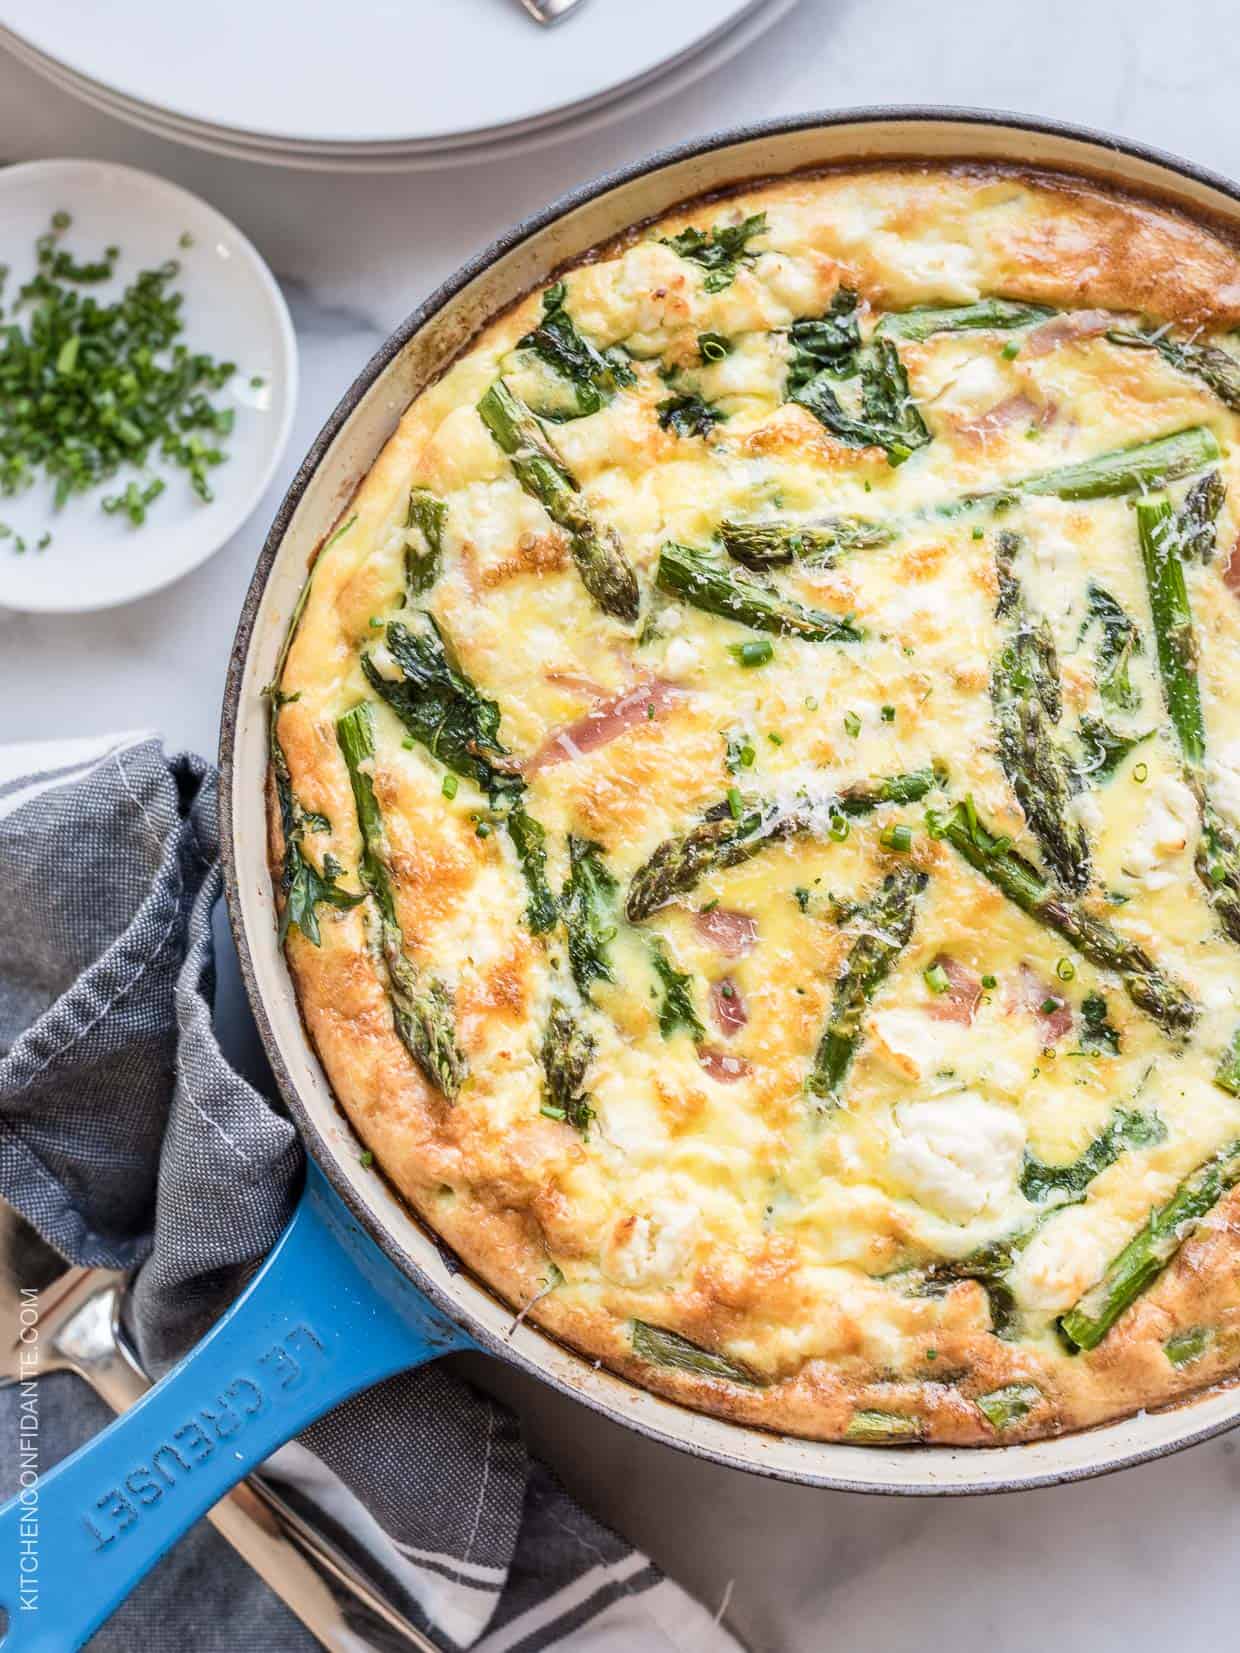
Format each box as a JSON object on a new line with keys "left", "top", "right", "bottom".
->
{"left": 269, "top": 167, "right": 1240, "bottom": 1445}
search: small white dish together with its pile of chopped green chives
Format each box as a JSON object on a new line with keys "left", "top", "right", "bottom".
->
{"left": 0, "top": 160, "right": 298, "bottom": 613}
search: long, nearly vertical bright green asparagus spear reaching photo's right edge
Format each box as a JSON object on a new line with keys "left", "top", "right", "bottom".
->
{"left": 1136, "top": 494, "right": 1240, "bottom": 942}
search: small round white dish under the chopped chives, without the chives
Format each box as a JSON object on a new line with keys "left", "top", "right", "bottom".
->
{"left": 0, "top": 160, "right": 298, "bottom": 613}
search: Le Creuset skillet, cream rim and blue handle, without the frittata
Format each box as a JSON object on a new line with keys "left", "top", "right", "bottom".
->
{"left": 0, "top": 109, "right": 1240, "bottom": 1653}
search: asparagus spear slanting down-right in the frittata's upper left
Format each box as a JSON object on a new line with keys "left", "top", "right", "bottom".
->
{"left": 478, "top": 379, "right": 638, "bottom": 622}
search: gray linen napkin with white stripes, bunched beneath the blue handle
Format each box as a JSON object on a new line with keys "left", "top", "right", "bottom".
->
{"left": 0, "top": 734, "right": 736, "bottom": 1653}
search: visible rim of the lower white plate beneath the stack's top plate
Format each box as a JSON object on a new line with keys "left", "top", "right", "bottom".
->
{"left": 0, "top": 0, "right": 797, "bottom": 172}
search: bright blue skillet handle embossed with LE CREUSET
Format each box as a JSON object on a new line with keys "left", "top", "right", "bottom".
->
{"left": 0, "top": 1164, "right": 473, "bottom": 1653}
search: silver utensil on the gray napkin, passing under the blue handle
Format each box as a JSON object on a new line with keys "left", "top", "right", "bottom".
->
{"left": 56, "top": 1271, "right": 440, "bottom": 1653}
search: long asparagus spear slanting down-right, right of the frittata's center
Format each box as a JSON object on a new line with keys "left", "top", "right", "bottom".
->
{"left": 926, "top": 797, "right": 1197, "bottom": 1033}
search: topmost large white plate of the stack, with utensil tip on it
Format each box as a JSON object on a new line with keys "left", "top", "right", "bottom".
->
{"left": 0, "top": 0, "right": 759, "bottom": 145}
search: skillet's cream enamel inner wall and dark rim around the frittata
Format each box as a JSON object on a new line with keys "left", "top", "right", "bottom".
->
{"left": 220, "top": 107, "right": 1240, "bottom": 1496}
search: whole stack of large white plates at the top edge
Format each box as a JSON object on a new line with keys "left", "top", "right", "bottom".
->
{"left": 0, "top": 0, "right": 795, "bottom": 172}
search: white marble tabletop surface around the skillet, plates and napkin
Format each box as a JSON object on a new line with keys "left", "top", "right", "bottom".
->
{"left": 0, "top": 0, "right": 1240, "bottom": 1653}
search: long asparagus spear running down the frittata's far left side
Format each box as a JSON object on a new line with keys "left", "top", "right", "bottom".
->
{"left": 336, "top": 701, "right": 468, "bottom": 1101}
